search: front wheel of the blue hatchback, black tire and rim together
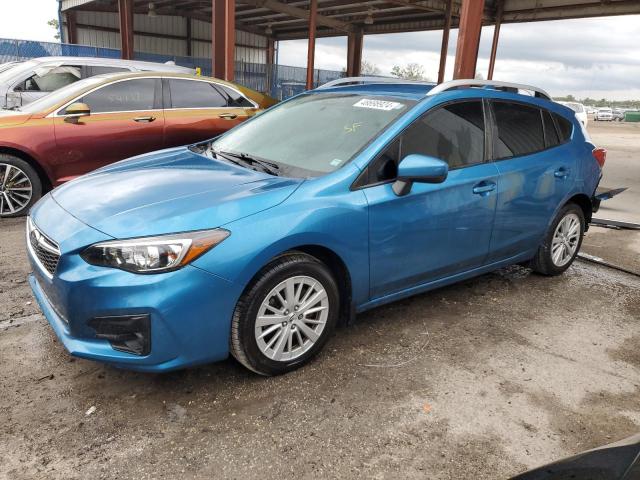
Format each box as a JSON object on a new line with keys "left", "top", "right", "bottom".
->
{"left": 230, "top": 252, "right": 340, "bottom": 375}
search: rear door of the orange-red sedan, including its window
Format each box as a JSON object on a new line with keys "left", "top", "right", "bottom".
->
{"left": 163, "top": 78, "right": 254, "bottom": 147}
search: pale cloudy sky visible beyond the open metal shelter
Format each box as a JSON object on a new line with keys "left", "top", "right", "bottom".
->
{"left": 0, "top": 0, "right": 640, "bottom": 100}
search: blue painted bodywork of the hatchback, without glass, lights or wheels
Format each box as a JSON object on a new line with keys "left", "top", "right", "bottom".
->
{"left": 30, "top": 84, "right": 601, "bottom": 372}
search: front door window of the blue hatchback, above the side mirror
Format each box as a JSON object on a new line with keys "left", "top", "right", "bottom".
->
{"left": 400, "top": 100, "right": 484, "bottom": 169}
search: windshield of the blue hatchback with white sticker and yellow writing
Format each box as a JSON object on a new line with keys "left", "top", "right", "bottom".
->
{"left": 211, "top": 93, "right": 416, "bottom": 177}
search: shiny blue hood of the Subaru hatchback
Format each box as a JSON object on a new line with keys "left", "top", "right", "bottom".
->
{"left": 52, "top": 147, "right": 303, "bottom": 238}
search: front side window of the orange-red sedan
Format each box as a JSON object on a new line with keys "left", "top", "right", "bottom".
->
{"left": 76, "top": 78, "right": 156, "bottom": 113}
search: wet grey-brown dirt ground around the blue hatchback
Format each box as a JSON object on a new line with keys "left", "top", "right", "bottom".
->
{"left": 0, "top": 121, "right": 640, "bottom": 480}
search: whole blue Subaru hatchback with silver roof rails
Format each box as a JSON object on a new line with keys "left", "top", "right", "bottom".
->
{"left": 27, "top": 80, "right": 605, "bottom": 375}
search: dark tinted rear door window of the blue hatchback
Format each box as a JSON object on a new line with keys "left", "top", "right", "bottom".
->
{"left": 492, "top": 102, "right": 545, "bottom": 160}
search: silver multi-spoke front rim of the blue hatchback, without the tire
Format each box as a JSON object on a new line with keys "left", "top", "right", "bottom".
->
{"left": 255, "top": 276, "right": 329, "bottom": 362}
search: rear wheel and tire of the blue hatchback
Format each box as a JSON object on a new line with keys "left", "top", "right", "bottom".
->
{"left": 531, "top": 203, "right": 585, "bottom": 275}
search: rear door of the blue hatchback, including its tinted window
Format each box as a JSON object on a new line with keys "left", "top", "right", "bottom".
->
{"left": 490, "top": 100, "right": 576, "bottom": 261}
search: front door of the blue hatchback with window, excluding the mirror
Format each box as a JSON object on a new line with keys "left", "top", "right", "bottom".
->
{"left": 363, "top": 100, "right": 498, "bottom": 299}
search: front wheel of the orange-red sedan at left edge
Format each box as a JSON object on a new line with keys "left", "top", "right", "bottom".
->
{"left": 0, "top": 154, "right": 42, "bottom": 218}
